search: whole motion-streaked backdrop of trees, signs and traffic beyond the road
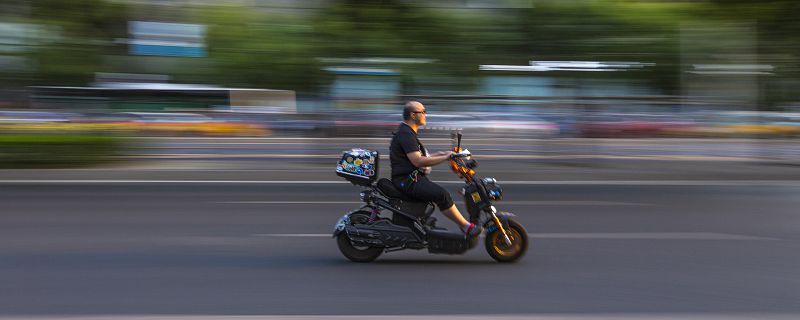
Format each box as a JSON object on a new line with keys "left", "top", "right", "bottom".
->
{"left": 0, "top": 0, "right": 800, "bottom": 148}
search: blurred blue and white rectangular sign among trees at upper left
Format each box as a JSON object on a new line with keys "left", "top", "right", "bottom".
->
{"left": 128, "top": 21, "right": 206, "bottom": 57}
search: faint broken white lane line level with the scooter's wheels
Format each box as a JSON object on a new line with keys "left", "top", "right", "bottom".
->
{"left": 251, "top": 232, "right": 780, "bottom": 241}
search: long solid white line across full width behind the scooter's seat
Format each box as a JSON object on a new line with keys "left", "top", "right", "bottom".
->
{"left": 0, "top": 179, "right": 800, "bottom": 187}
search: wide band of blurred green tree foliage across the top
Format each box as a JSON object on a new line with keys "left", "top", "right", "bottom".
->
{"left": 6, "top": 0, "right": 800, "bottom": 105}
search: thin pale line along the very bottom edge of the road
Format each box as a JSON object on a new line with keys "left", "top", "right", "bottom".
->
{"left": 0, "top": 312, "right": 800, "bottom": 320}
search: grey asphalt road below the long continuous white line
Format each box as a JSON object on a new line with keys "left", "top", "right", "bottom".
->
{"left": 0, "top": 181, "right": 800, "bottom": 316}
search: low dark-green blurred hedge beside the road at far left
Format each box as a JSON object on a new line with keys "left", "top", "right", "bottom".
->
{"left": 0, "top": 134, "right": 123, "bottom": 168}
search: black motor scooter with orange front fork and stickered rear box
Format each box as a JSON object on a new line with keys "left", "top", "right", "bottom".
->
{"left": 333, "top": 132, "right": 528, "bottom": 262}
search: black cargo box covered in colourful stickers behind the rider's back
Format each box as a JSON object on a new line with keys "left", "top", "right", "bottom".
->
{"left": 336, "top": 149, "right": 378, "bottom": 187}
